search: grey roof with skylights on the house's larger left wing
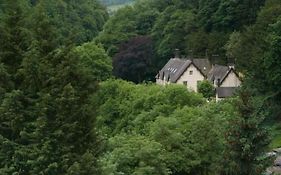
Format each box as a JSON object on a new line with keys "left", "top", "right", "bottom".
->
{"left": 157, "top": 58, "right": 211, "bottom": 83}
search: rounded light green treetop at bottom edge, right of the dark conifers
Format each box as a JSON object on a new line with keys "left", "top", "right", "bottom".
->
{"left": 100, "top": 134, "right": 169, "bottom": 175}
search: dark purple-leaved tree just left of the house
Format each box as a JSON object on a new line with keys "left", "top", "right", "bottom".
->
{"left": 113, "top": 36, "right": 154, "bottom": 83}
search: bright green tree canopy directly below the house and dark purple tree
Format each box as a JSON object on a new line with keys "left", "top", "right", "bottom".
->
{"left": 94, "top": 80, "right": 203, "bottom": 135}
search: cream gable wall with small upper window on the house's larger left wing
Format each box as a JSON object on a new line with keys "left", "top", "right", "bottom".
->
{"left": 176, "top": 64, "right": 205, "bottom": 92}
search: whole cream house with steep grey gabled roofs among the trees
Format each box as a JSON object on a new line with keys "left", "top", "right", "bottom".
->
{"left": 156, "top": 58, "right": 241, "bottom": 101}
